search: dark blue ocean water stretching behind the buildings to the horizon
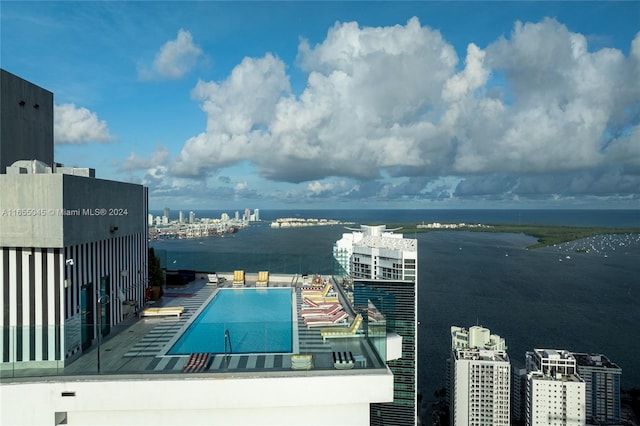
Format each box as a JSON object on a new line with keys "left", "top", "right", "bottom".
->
{"left": 151, "top": 210, "right": 640, "bottom": 416}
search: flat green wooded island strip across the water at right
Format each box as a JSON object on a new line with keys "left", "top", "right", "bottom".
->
{"left": 388, "top": 223, "right": 640, "bottom": 249}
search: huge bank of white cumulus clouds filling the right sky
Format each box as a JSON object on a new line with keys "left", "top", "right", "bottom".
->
{"left": 171, "top": 18, "right": 640, "bottom": 203}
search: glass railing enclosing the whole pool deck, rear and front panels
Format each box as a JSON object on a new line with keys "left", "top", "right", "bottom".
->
{"left": 0, "top": 252, "right": 386, "bottom": 381}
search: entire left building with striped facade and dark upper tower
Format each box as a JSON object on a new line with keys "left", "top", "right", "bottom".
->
{"left": 0, "top": 70, "right": 148, "bottom": 370}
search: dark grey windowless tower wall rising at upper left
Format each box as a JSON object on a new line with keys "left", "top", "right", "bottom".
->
{"left": 0, "top": 70, "right": 53, "bottom": 173}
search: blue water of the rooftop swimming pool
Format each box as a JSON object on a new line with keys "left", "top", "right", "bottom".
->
{"left": 168, "top": 288, "right": 293, "bottom": 355}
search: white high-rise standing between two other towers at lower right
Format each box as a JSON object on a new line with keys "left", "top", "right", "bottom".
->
{"left": 526, "top": 349, "right": 586, "bottom": 426}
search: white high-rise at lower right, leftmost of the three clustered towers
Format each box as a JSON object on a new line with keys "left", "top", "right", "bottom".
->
{"left": 449, "top": 326, "right": 511, "bottom": 425}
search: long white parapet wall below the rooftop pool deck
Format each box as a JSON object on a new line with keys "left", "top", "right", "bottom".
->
{"left": 0, "top": 370, "right": 393, "bottom": 425}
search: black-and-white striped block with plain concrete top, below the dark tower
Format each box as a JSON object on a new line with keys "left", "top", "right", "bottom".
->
{"left": 0, "top": 173, "right": 148, "bottom": 368}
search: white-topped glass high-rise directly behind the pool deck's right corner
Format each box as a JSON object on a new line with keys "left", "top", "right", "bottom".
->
{"left": 334, "top": 225, "right": 418, "bottom": 426}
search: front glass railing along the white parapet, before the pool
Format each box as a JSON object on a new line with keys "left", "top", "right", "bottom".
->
{"left": 0, "top": 320, "right": 384, "bottom": 381}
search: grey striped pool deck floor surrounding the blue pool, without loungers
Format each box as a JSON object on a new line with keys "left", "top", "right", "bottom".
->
{"left": 2, "top": 276, "right": 385, "bottom": 378}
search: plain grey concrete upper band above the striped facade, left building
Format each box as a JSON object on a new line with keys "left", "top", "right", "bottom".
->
{"left": 0, "top": 173, "right": 147, "bottom": 248}
